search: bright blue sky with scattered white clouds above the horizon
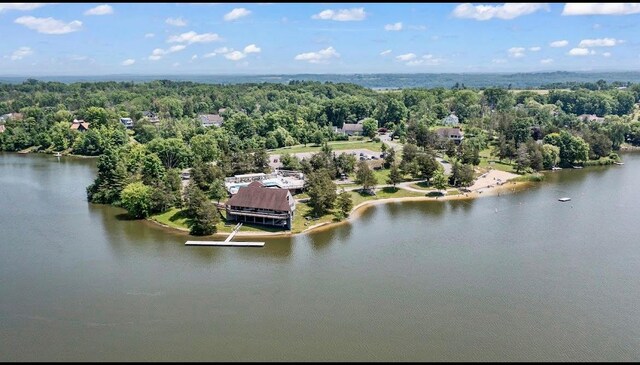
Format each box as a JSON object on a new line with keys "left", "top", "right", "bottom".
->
{"left": 0, "top": 3, "right": 640, "bottom": 76}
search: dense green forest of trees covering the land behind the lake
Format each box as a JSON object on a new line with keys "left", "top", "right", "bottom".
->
{"left": 0, "top": 79, "right": 640, "bottom": 232}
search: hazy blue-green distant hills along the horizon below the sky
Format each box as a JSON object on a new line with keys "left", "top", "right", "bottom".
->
{"left": 0, "top": 71, "right": 640, "bottom": 89}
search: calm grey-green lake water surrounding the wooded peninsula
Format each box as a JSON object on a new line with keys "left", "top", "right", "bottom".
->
{"left": 0, "top": 154, "right": 640, "bottom": 361}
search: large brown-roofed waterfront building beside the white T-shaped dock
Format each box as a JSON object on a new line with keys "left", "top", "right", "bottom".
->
{"left": 226, "top": 181, "right": 296, "bottom": 230}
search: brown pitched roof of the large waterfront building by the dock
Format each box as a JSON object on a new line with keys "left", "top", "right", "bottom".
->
{"left": 227, "top": 181, "right": 291, "bottom": 212}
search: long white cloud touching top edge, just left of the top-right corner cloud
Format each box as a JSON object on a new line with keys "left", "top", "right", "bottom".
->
{"left": 453, "top": 3, "right": 549, "bottom": 20}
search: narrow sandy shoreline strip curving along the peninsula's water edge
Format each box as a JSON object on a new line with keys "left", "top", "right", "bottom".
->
{"left": 145, "top": 176, "right": 532, "bottom": 238}
